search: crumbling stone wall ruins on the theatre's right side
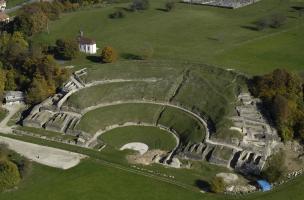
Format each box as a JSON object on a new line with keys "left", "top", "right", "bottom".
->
{"left": 176, "top": 93, "right": 280, "bottom": 174}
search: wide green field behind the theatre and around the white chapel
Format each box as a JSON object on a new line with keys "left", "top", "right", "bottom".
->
{"left": 32, "top": 0, "right": 304, "bottom": 74}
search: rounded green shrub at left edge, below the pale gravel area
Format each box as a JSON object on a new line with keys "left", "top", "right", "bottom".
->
{"left": 0, "top": 160, "right": 21, "bottom": 191}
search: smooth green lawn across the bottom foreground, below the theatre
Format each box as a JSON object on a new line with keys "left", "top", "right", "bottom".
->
{"left": 0, "top": 160, "right": 304, "bottom": 200}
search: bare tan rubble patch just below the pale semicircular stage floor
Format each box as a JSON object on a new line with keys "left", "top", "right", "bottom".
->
{"left": 127, "top": 149, "right": 167, "bottom": 165}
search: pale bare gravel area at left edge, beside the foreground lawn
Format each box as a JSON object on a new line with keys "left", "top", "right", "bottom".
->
{"left": 0, "top": 136, "right": 86, "bottom": 169}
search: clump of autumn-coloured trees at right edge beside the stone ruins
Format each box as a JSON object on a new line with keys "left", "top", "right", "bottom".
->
{"left": 251, "top": 69, "right": 304, "bottom": 141}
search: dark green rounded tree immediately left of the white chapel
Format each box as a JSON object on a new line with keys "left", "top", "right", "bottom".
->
{"left": 56, "top": 39, "right": 79, "bottom": 60}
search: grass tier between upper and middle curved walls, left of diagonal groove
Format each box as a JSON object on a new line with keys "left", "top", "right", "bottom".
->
{"left": 65, "top": 80, "right": 172, "bottom": 109}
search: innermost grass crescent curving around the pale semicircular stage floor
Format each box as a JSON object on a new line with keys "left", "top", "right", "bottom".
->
{"left": 100, "top": 126, "right": 176, "bottom": 151}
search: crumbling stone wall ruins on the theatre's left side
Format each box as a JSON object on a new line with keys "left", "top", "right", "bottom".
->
{"left": 22, "top": 69, "right": 91, "bottom": 145}
